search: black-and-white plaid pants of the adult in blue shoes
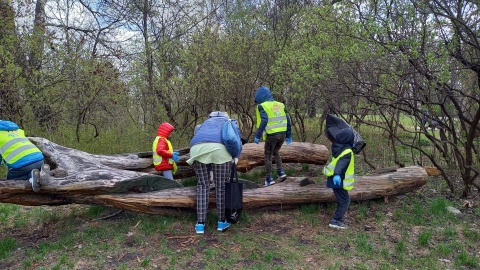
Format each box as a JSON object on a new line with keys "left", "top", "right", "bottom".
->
{"left": 193, "top": 161, "right": 232, "bottom": 223}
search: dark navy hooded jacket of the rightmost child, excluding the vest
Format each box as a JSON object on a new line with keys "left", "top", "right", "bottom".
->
{"left": 327, "top": 128, "right": 355, "bottom": 189}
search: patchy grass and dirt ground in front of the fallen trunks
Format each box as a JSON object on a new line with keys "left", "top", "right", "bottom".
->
{"left": 0, "top": 189, "right": 479, "bottom": 269}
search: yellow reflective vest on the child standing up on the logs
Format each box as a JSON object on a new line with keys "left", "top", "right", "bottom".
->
{"left": 256, "top": 101, "right": 287, "bottom": 139}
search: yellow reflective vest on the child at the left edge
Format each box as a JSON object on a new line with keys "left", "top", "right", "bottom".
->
{"left": 0, "top": 129, "right": 41, "bottom": 164}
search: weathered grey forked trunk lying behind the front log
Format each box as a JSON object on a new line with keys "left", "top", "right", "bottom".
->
{"left": 0, "top": 137, "right": 328, "bottom": 197}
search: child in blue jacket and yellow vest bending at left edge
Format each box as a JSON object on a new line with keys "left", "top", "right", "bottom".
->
{"left": 0, "top": 120, "right": 50, "bottom": 192}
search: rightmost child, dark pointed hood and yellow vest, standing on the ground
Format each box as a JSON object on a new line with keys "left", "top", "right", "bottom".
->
{"left": 323, "top": 128, "right": 355, "bottom": 229}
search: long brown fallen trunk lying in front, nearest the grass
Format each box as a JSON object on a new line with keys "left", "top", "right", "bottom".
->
{"left": 0, "top": 166, "right": 428, "bottom": 214}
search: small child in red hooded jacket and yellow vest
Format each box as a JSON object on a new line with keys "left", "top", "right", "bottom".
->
{"left": 152, "top": 122, "right": 180, "bottom": 180}
